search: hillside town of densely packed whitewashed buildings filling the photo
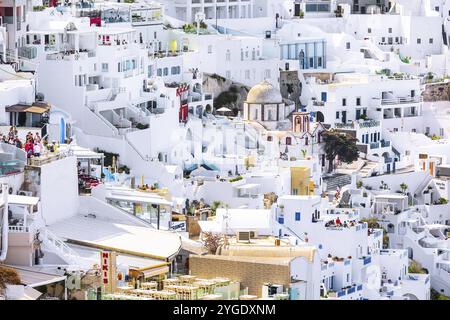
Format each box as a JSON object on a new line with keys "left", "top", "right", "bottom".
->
{"left": 0, "top": 0, "right": 450, "bottom": 300}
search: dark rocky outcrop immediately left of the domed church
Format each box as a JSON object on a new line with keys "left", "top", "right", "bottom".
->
{"left": 203, "top": 73, "right": 250, "bottom": 115}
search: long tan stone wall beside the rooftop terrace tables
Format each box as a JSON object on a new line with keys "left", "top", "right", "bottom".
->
{"left": 189, "top": 255, "right": 290, "bottom": 297}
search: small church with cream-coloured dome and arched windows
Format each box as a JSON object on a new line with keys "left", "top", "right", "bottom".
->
{"left": 244, "top": 80, "right": 288, "bottom": 124}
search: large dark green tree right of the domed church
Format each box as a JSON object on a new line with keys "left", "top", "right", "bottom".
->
{"left": 322, "top": 130, "right": 359, "bottom": 172}
